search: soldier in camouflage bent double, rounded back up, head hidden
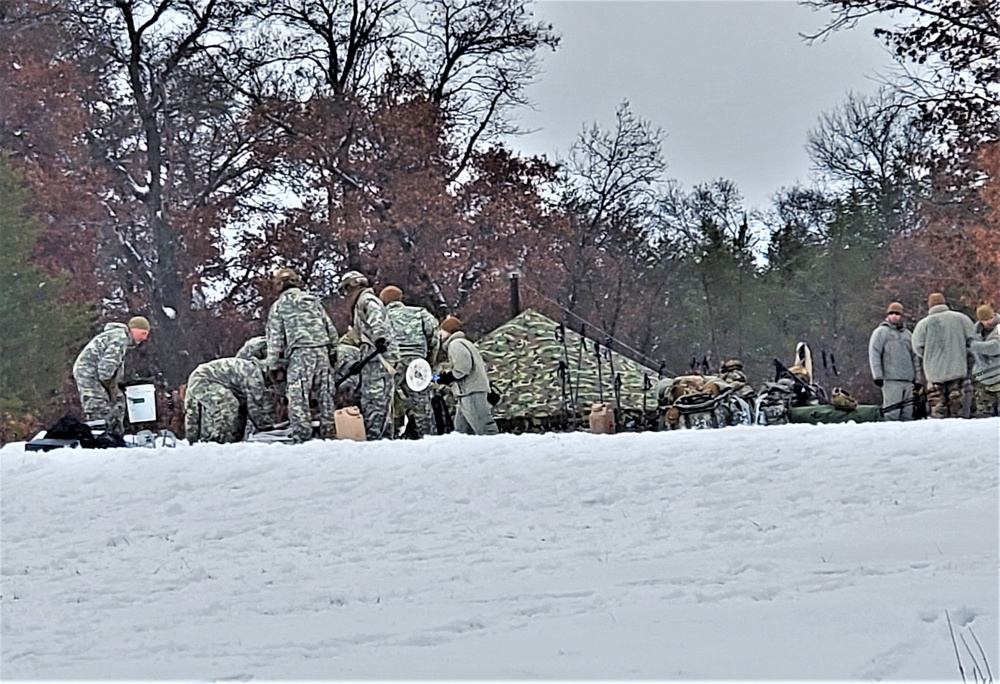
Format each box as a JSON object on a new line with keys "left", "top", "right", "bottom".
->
{"left": 184, "top": 358, "right": 275, "bottom": 444}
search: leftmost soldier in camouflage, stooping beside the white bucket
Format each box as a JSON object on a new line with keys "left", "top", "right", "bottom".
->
{"left": 73, "top": 316, "right": 149, "bottom": 437}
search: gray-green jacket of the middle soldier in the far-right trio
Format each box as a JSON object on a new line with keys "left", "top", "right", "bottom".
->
{"left": 913, "top": 304, "right": 974, "bottom": 382}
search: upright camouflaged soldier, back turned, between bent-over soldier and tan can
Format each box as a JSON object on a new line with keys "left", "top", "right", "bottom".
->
{"left": 265, "top": 268, "right": 339, "bottom": 442}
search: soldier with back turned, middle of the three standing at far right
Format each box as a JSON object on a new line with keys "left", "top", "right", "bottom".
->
{"left": 913, "top": 292, "right": 974, "bottom": 418}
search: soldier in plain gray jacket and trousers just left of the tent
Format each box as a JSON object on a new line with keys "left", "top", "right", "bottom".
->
{"left": 438, "top": 316, "right": 500, "bottom": 435}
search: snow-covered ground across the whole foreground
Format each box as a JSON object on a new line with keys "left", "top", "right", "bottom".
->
{"left": 0, "top": 419, "right": 1000, "bottom": 681}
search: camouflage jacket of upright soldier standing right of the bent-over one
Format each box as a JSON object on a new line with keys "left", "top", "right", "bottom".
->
{"left": 266, "top": 287, "right": 340, "bottom": 368}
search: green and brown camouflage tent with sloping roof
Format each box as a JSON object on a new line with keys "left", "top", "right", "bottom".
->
{"left": 476, "top": 309, "right": 658, "bottom": 427}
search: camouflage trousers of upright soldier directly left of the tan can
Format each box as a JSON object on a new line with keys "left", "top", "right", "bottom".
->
{"left": 285, "top": 347, "right": 336, "bottom": 442}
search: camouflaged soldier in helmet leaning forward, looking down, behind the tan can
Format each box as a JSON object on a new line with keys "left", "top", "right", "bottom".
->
{"left": 337, "top": 271, "right": 399, "bottom": 439}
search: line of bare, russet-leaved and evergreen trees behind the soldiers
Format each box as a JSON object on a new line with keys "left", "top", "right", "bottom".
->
{"left": 0, "top": 0, "right": 1000, "bottom": 438}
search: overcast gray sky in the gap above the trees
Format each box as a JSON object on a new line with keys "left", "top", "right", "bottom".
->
{"left": 512, "top": 0, "right": 890, "bottom": 208}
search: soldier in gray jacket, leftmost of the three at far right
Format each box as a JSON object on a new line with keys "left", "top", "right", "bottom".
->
{"left": 868, "top": 302, "right": 917, "bottom": 420}
